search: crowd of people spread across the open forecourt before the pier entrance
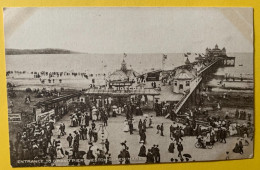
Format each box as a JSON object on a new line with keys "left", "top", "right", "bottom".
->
{"left": 10, "top": 88, "right": 252, "bottom": 166}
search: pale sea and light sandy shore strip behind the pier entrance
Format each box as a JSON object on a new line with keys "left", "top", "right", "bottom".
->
{"left": 6, "top": 53, "right": 254, "bottom": 90}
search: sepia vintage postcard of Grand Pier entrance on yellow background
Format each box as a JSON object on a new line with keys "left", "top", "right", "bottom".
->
{"left": 4, "top": 7, "right": 254, "bottom": 167}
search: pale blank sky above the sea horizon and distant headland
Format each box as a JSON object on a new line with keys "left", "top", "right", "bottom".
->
{"left": 4, "top": 7, "right": 253, "bottom": 54}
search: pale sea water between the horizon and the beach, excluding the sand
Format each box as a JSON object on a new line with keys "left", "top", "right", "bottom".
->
{"left": 6, "top": 53, "right": 254, "bottom": 77}
